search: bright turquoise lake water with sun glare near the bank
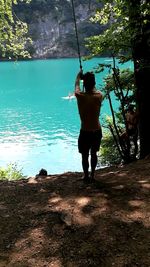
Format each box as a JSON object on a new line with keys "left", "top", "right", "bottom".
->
{"left": 0, "top": 58, "right": 133, "bottom": 176}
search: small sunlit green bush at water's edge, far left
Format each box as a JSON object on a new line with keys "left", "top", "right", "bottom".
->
{"left": 0, "top": 163, "right": 24, "bottom": 181}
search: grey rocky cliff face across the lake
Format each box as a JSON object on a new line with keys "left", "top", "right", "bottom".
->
{"left": 16, "top": 0, "right": 102, "bottom": 58}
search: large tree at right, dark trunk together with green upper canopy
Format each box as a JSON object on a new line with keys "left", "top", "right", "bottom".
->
{"left": 87, "top": 0, "right": 150, "bottom": 158}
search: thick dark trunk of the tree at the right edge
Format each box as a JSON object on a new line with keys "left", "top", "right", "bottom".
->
{"left": 129, "top": 0, "right": 150, "bottom": 158}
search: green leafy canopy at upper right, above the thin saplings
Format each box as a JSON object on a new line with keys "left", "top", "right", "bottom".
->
{"left": 86, "top": 0, "right": 150, "bottom": 61}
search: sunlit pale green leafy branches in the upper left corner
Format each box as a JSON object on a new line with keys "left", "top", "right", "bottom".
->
{"left": 0, "top": 0, "right": 31, "bottom": 59}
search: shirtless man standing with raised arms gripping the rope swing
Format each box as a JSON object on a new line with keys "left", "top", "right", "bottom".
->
{"left": 75, "top": 72, "right": 102, "bottom": 182}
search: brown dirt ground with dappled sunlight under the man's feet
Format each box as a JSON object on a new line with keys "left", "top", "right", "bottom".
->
{"left": 0, "top": 158, "right": 150, "bottom": 267}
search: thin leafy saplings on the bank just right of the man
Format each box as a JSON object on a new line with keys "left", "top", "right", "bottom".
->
{"left": 96, "top": 59, "right": 136, "bottom": 165}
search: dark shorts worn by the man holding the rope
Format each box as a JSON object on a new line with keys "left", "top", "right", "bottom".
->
{"left": 78, "top": 129, "right": 102, "bottom": 153}
